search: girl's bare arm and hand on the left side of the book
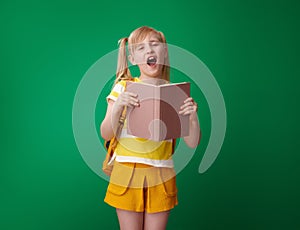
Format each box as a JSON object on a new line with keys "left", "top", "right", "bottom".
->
{"left": 100, "top": 92, "right": 139, "bottom": 140}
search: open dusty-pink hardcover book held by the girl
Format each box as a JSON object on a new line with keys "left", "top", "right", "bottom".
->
{"left": 126, "top": 82, "right": 190, "bottom": 141}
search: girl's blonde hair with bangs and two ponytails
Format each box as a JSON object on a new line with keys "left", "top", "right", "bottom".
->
{"left": 115, "top": 26, "right": 170, "bottom": 84}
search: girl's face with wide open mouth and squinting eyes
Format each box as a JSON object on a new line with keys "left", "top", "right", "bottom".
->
{"left": 129, "top": 33, "right": 167, "bottom": 79}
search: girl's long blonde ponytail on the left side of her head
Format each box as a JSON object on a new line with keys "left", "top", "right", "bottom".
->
{"left": 115, "top": 38, "right": 132, "bottom": 84}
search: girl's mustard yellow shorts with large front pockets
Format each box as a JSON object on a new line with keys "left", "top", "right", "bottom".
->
{"left": 104, "top": 161, "right": 178, "bottom": 213}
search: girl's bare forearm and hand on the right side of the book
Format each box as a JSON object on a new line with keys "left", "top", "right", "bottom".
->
{"left": 179, "top": 97, "right": 201, "bottom": 148}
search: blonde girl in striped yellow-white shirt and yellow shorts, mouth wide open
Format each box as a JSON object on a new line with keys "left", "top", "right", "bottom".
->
{"left": 100, "top": 26, "right": 200, "bottom": 230}
